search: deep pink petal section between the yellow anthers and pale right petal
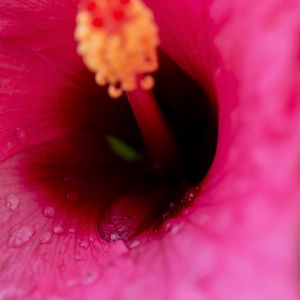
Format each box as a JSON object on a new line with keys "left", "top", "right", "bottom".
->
{"left": 145, "top": 0, "right": 218, "bottom": 89}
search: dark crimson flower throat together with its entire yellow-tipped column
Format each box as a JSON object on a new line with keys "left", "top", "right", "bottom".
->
{"left": 24, "top": 0, "right": 217, "bottom": 242}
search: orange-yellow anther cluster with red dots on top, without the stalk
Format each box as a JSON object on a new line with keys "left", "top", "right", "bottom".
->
{"left": 75, "top": 0, "right": 159, "bottom": 98}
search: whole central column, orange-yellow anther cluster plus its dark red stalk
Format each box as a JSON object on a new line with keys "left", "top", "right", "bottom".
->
{"left": 75, "top": 0, "right": 176, "bottom": 171}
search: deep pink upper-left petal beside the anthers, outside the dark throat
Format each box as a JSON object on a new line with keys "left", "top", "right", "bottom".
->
{"left": 0, "top": 1, "right": 85, "bottom": 160}
